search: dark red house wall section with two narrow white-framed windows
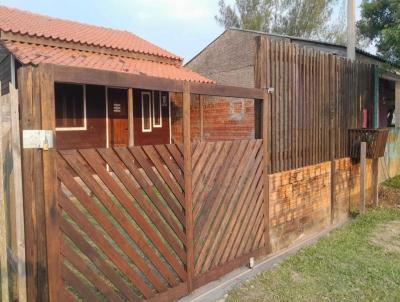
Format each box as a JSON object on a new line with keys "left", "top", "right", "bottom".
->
{"left": 133, "top": 90, "right": 170, "bottom": 146}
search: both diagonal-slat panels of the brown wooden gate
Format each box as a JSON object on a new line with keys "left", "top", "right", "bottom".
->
{"left": 51, "top": 140, "right": 265, "bottom": 301}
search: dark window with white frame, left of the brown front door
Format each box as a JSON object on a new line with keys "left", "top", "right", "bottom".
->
{"left": 54, "top": 83, "right": 86, "bottom": 131}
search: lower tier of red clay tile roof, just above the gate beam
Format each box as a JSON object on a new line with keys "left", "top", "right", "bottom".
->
{"left": 3, "top": 41, "right": 213, "bottom": 83}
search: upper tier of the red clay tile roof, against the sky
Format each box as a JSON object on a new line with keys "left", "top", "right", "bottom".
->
{"left": 0, "top": 6, "right": 181, "bottom": 60}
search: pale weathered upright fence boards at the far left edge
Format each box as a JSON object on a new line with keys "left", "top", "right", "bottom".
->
{"left": 0, "top": 85, "right": 27, "bottom": 302}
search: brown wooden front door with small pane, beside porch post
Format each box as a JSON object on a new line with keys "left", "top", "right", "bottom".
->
{"left": 107, "top": 88, "right": 129, "bottom": 147}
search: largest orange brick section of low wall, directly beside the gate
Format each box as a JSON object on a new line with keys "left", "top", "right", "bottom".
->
{"left": 269, "top": 162, "right": 330, "bottom": 251}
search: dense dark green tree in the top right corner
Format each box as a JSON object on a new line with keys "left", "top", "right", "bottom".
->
{"left": 357, "top": 0, "right": 400, "bottom": 65}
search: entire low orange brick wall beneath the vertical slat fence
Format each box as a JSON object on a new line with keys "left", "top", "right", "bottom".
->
{"left": 269, "top": 158, "right": 372, "bottom": 251}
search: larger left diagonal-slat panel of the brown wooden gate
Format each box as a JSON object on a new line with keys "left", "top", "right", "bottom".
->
{"left": 56, "top": 145, "right": 187, "bottom": 301}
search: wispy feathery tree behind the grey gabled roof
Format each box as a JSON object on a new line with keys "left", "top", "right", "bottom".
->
{"left": 215, "top": 0, "right": 345, "bottom": 42}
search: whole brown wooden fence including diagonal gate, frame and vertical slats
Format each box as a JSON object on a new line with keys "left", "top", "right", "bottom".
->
{"left": 14, "top": 56, "right": 378, "bottom": 301}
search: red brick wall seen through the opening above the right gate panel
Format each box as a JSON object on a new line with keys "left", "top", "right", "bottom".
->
{"left": 171, "top": 93, "right": 255, "bottom": 143}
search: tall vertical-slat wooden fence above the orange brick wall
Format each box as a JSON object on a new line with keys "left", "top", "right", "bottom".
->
{"left": 255, "top": 37, "right": 374, "bottom": 173}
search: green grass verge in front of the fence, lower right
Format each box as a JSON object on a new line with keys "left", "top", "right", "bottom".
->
{"left": 226, "top": 209, "right": 400, "bottom": 302}
